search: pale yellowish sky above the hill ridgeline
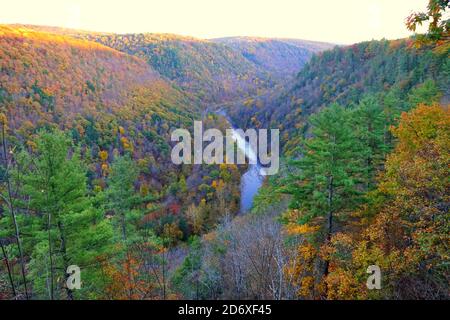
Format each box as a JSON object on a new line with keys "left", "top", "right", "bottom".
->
{"left": 0, "top": 0, "right": 428, "bottom": 44}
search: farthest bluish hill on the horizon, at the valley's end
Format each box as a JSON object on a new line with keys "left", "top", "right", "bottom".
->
{"left": 212, "top": 37, "right": 334, "bottom": 80}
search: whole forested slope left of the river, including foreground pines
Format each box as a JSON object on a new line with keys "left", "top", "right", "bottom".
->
{"left": 0, "top": 26, "right": 244, "bottom": 299}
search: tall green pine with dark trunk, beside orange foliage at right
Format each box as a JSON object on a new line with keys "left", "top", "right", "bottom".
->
{"left": 284, "top": 104, "right": 363, "bottom": 294}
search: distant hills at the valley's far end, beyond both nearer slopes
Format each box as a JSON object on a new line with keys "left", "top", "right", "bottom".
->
{"left": 5, "top": 25, "right": 333, "bottom": 104}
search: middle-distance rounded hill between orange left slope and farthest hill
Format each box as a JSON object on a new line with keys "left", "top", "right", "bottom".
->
{"left": 80, "top": 34, "right": 273, "bottom": 103}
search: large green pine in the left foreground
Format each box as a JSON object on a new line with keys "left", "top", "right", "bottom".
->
{"left": 23, "top": 130, "right": 112, "bottom": 299}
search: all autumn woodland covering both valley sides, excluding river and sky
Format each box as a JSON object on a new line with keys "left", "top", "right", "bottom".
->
{"left": 0, "top": 0, "right": 450, "bottom": 300}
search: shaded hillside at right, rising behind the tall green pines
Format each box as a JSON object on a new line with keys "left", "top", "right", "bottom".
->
{"left": 231, "top": 40, "right": 450, "bottom": 149}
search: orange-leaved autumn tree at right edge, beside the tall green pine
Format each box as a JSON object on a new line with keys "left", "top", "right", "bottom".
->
{"left": 327, "top": 105, "right": 450, "bottom": 299}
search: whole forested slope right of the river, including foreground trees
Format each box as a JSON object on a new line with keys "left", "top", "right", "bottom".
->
{"left": 216, "top": 5, "right": 450, "bottom": 299}
